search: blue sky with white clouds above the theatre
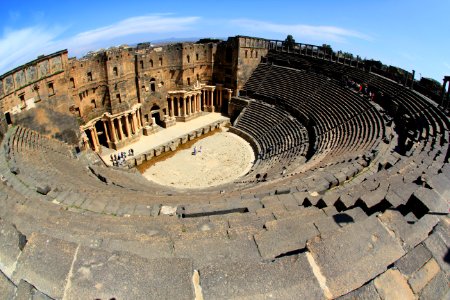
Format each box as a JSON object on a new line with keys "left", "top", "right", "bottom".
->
{"left": 0, "top": 0, "right": 450, "bottom": 82}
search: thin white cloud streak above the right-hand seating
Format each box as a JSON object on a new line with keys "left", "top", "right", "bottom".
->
{"left": 231, "top": 19, "right": 371, "bottom": 42}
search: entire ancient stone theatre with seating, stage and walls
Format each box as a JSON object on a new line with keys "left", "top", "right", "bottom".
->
{"left": 0, "top": 36, "right": 450, "bottom": 299}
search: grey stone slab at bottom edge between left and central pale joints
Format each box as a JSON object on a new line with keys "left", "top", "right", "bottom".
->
{"left": 64, "top": 247, "right": 194, "bottom": 299}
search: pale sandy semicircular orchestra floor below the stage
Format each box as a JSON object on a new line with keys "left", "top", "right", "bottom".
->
{"left": 142, "top": 128, "right": 255, "bottom": 188}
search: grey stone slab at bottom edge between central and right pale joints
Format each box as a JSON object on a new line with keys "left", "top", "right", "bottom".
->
{"left": 199, "top": 253, "right": 325, "bottom": 299}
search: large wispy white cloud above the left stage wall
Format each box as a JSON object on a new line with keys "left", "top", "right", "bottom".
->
{"left": 0, "top": 14, "right": 199, "bottom": 74}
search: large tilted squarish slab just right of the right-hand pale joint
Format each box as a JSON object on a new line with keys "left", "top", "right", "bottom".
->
{"left": 307, "top": 216, "right": 405, "bottom": 298}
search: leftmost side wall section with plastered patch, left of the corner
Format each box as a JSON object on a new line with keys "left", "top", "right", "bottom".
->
{"left": 0, "top": 50, "right": 78, "bottom": 143}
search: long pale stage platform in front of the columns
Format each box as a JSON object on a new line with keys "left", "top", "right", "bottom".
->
{"left": 101, "top": 113, "right": 229, "bottom": 165}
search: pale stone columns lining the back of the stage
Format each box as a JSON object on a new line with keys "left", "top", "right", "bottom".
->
{"left": 80, "top": 83, "right": 233, "bottom": 152}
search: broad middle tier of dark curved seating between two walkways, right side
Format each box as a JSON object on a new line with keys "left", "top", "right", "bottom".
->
{"left": 243, "top": 63, "right": 385, "bottom": 172}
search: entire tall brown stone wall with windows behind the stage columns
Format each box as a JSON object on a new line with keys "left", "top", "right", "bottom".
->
{"left": 0, "top": 36, "right": 268, "bottom": 146}
